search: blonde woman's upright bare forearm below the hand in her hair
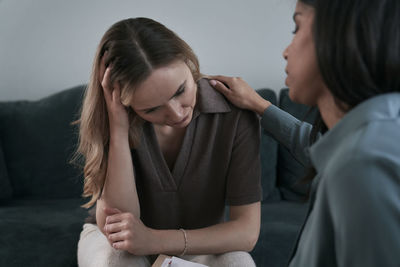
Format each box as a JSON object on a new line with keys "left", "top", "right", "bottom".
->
{"left": 96, "top": 134, "right": 140, "bottom": 229}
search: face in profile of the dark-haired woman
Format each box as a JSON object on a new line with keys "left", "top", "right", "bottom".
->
{"left": 283, "top": 1, "right": 324, "bottom": 106}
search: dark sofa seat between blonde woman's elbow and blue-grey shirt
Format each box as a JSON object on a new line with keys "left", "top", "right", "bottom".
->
{"left": 250, "top": 201, "right": 308, "bottom": 267}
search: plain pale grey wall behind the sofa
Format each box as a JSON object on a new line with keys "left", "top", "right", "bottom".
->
{"left": 0, "top": 0, "right": 295, "bottom": 101}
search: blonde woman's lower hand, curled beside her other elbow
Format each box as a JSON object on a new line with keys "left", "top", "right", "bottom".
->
{"left": 104, "top": 208, "right": 157, "bottom": 255}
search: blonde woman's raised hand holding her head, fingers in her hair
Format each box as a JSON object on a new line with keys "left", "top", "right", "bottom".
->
{"left": 99, "top": 54, "right": 129, "bottom": 138}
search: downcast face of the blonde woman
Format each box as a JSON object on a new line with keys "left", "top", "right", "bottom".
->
{"left": 131, "top": 61, "right": 197, "bottom": 128}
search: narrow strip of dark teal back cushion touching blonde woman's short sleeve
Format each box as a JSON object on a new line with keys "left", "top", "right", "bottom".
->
{"left": 257, "top": 88, "right": 280, "bottom": 201}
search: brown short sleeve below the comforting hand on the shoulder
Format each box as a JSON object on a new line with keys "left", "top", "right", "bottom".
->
{"left": 226, "top": 110, "right": 262, "bottom": 206}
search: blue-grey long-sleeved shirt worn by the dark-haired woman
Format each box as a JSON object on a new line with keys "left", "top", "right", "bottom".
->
{"left": 262, "top": 93, "right": 400, "bottom": 267}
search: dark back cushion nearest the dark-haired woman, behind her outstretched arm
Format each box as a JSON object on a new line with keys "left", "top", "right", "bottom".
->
{"left": 277, "top": 89, "right": 316, "bottom": 200}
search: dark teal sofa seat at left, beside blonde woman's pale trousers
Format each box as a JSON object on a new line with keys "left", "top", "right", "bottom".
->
{"left": 0, "top": 199, "right": 87, "bottom": 267}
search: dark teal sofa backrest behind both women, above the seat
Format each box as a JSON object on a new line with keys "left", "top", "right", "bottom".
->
{"left": 0, "top": 85, "right": 315, "bottom": 201}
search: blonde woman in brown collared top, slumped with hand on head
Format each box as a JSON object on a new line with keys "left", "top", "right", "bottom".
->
{"left": 78, "top": 18, "right": 261, "bottom": 267}
